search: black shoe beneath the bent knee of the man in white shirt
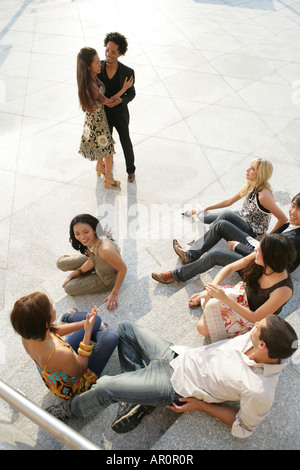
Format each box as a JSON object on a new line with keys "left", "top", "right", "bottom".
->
{"left": 111, "top": 403, "right": 155, "bottom": 433}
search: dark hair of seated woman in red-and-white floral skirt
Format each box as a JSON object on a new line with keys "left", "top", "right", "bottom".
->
{"left": 242, "top": 233, "right": 296, "bottom": 291}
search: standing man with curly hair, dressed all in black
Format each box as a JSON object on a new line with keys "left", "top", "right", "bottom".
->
{"left": 98, "top": 33, "right": 135, "bottom": 183}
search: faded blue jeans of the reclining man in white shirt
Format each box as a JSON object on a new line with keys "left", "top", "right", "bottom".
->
{"left": 67, "top": 321, "right": 178, "bottom": 417}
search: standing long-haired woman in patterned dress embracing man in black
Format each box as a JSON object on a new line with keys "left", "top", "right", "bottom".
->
{"left": 77, "top": 47, "right": 133, "bottom": 188}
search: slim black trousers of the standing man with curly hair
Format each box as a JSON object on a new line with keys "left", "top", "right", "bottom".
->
{"left": 105, "top": 106, "right": 135, "bottom": 174}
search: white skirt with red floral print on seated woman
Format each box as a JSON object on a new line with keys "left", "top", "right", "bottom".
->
{"left": 204, "top": 281, "right": 254, "bottom": 342}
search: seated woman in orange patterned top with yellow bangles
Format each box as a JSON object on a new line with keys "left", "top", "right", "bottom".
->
{"left": 11, "top": 292, "right": 119, "bottom": 399}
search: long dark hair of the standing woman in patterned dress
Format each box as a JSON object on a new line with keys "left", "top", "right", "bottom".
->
{"left": 77, "top": 47, "right": 97, "bottom": 112}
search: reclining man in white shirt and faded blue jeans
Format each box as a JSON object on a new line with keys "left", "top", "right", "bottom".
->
{"left": 48, "top": 315, "right": 297, "bottom": 438}
